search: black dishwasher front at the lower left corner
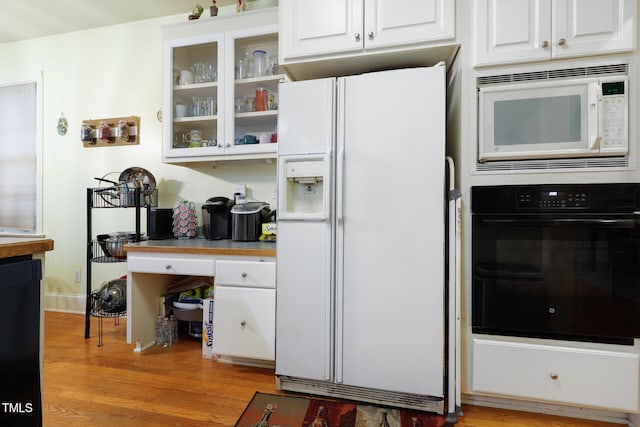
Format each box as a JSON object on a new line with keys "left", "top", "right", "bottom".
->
{"left": 0, "top": 256, "right": 42, "bottom": 426}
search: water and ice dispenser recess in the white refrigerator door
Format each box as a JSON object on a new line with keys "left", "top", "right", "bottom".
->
{"left": 278, "top": 156, "right": 328, "bottom": 219}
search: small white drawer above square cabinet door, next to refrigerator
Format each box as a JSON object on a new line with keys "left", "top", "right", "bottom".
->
{"left": 216, "top": 261, "right": 276, "bottom": 288}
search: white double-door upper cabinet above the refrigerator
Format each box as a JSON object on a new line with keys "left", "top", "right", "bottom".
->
{"left": 280, "top": 0, "right": 455, "bottom": 63}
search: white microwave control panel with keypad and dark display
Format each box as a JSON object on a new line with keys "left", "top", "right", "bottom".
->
{"left": 601, "top": 80, "right": 628, "bottom": 152}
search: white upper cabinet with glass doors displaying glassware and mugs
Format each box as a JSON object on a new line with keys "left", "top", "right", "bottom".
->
{"left": 163, "top": 8, "right": 284, "bottom": 163}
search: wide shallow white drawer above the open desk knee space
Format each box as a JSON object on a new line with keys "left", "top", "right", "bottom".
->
{"left": 127, "top": 253, "right": 215, "bottom": 276}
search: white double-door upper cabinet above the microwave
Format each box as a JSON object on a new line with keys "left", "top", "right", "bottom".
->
{"left": 473, "top": 0, "right": 637, "bottom": 65}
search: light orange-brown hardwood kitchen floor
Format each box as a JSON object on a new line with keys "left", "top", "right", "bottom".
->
{"left": 43, "top": 312, "right": 620, "bottom": 427}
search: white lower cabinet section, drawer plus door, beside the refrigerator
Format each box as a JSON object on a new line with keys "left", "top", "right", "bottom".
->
{"left": 213, "top": 261, "right": 276, "bottom": 362}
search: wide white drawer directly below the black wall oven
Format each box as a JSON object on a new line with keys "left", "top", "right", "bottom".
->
{"left": 473, "top": 339, "right": 639, "bottom": 412}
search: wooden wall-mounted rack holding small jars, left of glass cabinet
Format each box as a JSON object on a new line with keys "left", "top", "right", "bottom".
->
{"left": 80, "top": 116, "right": 140, "bottom": 147}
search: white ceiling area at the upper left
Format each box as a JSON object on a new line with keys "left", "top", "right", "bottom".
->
{"left": 0, "top": 0, "right": 235, "bottom": 43}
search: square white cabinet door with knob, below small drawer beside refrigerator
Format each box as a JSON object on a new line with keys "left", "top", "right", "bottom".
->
{"left": 213, "top": 286, "right": 276, "bottom": 361}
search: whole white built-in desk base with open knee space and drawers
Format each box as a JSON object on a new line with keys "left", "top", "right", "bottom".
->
{"left": 127, "top": 250, "right": 276, "bottom": 366}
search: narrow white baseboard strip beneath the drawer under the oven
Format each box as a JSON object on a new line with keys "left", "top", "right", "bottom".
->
{"left": 462, "top": 394, "right": 640, "bottom": 427}
